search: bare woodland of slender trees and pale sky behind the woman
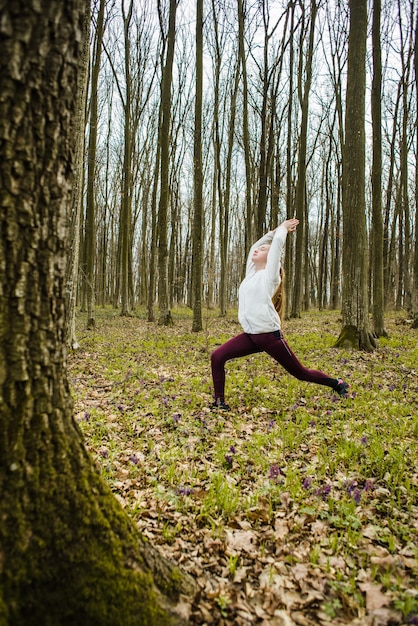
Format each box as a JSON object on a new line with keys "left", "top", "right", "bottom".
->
{"left": 68, "top": 0, "right": 418, "bottom": 336}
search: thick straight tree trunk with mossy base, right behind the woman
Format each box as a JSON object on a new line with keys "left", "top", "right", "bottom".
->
{"left": 336, "top": 0, "right": 375, "bottom": 350}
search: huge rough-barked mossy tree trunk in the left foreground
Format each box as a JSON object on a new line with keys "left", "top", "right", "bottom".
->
{"left": 0, "top": 0, "right": 193, "bottom": 626}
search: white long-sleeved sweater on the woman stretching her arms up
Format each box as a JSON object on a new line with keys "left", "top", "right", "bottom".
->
{"left": 238, "top": 226, "right": 287, "bottom": 335}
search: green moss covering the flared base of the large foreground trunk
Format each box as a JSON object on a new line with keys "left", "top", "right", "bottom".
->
{"left": 0, "top": 436, "right": 182, "bottom": 626}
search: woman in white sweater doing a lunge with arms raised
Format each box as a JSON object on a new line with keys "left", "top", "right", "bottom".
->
{"left": 211, "top": 219, "right": 350, "bottom": 410}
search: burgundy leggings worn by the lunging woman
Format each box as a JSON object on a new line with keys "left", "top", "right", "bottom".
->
{"left": 211, "top": 330, "right": 338, "bottom": 401}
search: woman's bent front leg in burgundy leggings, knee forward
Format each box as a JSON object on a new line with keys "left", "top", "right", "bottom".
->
{"left": 211, "top": 333, "right": 263, "bottom": 403}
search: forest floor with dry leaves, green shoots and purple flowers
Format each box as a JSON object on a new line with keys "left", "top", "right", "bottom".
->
{"left": 69, "top": 309, "right": 418, "bottom": 626}
